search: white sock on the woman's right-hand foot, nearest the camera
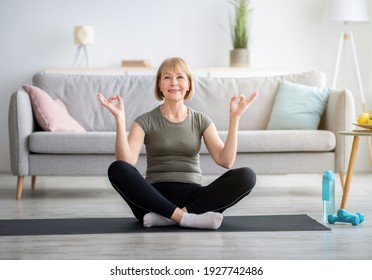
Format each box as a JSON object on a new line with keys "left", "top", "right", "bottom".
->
{"left": 180, "top": 212, "right": 223, "bottom": 229}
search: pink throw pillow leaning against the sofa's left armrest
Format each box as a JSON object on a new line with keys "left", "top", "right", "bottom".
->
{"left": 22, "top": 85, "right": 86, "bottom": 132}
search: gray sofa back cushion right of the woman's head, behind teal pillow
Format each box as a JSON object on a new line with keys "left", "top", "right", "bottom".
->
{"left": 189, "top": 71, "right": 325, "bottom": 131}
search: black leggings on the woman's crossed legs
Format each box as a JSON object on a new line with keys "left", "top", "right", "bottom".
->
{"left": 108, "top": 160, "right": 256, "bottom": 221}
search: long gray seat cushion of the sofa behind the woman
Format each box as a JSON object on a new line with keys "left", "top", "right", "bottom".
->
{"left": 29, "top": 130, "right": 336, "bottom": 154}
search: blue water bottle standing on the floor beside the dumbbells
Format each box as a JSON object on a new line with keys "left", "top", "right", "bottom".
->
{"left": 322, "top": 170, "right": 335, "bottom": 220}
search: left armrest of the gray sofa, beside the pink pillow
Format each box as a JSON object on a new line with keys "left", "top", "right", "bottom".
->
{"left": 8, "top": 90, "right": 35, "bottom": 176}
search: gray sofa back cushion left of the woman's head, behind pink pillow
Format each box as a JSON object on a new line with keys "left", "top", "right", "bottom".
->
{"left": 33, "top": 72, "right": 160, "bottom": 131}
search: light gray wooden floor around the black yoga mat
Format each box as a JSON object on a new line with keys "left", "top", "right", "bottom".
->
{"left": 0, "top": 174, "right": 372, "bottom": 260}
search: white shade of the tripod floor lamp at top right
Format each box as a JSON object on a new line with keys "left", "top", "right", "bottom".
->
{"left": 326, "top": 0, "right": 369, "bottom": 22}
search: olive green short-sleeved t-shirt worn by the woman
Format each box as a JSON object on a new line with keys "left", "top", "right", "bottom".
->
{"left": 135, "top": 106, "right": 212, "bottom": 184}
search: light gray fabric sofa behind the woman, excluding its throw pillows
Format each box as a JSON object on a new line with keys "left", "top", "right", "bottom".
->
{"left": 9, "top": 71, "right": 355, "bottom": 199}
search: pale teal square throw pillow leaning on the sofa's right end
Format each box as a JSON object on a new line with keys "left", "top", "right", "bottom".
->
{"left": 267, "top": 80, "right": 330, "bottom": 130}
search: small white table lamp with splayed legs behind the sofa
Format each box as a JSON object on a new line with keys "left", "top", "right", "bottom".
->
{"left": 73, "top": 25, "right": 95, "bottom": 67}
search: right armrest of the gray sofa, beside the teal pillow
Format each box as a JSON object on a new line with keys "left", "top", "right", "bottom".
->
{"left": 324, "top": 90, "right": 355, "bottom": 173}
